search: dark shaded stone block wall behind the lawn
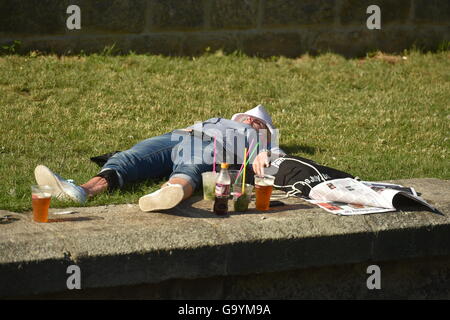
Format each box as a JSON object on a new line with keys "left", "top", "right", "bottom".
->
{"left": 0, "top": 0, "right": 450, "bottom": 57}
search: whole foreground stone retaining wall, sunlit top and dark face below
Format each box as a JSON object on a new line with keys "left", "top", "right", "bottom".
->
{"left": 0, "top": 179, "right": 450, "bottom": 299}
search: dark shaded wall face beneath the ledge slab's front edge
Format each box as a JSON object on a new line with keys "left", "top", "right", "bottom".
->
{"left": 22, "top": 257, "right": 450, "bottom": 298}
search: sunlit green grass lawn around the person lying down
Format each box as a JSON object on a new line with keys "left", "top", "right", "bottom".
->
{"left": 0, "top": 51, "right": 450, "bottom": 211}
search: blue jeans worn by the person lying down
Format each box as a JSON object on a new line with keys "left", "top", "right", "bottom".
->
{"left": 102, "top": 132, "right": 213, "bottom": 190}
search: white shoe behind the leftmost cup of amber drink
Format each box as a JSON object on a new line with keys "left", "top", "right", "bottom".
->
{"left": 34, "top": 165, "right": 87, "bottom": 203}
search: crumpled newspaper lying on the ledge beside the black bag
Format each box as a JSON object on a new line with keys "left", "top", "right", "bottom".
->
{"left": 305, "top": 178, "right": 441, "bottom": 215}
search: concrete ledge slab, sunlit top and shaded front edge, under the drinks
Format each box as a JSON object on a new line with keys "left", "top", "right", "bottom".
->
{"left": 0, "top": 179, "right": 450, "bottom": 298}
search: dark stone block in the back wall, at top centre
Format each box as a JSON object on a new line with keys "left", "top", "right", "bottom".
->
{"left": 210, "top": 0, "right": 258, "bottom": 29}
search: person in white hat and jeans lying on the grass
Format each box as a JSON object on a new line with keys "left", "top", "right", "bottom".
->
{"left": 34, "top": 105, "right": 285, "bottom": 211}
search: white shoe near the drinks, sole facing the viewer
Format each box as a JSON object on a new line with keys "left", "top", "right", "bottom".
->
{"left": 139, "top": 184, "right": 184, "bottom": 211}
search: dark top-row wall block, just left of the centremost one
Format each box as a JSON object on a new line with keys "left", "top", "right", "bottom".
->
{"left": 147, "top": 0, "right": 205, "bottom": 30}
